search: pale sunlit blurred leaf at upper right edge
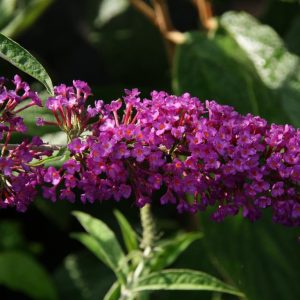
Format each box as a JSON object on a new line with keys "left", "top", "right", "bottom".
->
{"left": 220, "top": 12, "right": 300, "bottom": 127}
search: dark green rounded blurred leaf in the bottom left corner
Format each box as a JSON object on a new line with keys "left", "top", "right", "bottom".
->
{"left": 0, "top": 252, "right": 57, "bottom": 300}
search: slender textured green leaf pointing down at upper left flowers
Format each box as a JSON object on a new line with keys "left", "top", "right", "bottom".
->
{"left": 0, "top": 33, "right": 53, "bottom": 94}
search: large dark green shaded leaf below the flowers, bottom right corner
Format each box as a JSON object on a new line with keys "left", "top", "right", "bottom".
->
{"left": 198, "top": 211, "right": 300, "bottom": 300}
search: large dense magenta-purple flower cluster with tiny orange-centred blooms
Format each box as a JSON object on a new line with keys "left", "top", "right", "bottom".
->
{"left": 0, "top": 75, "right": 300, "bottom": 226}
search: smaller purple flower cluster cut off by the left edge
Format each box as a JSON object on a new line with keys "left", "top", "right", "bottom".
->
{"left": 0, "top": 75, "right": 51, "bottom": 211}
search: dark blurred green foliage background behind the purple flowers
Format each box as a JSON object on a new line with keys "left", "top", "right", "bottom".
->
{"left": 0, "top": 0, "right": 300, "bottom": 300}
